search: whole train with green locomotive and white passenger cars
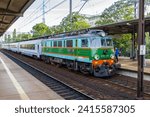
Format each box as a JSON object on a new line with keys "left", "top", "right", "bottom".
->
{"left": 2, "top": 30, "right": 120, "bottom": 77}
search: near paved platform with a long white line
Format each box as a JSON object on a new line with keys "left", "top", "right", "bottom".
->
{"left": 0, "top": 52, "right": 63, "bottom": 100}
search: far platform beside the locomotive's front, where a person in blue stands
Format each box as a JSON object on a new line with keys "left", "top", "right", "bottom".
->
{"left": 119, "top": 57, "right": 150, "bottom": 74}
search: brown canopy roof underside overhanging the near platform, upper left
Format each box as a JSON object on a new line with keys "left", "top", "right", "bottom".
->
{"left": 0, "top": 0, "right": 35, "bottom": 36}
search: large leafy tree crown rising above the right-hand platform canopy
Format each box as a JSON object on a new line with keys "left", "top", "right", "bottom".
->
{"left": 96, "top": 0, "right": 134, "bottom": 25}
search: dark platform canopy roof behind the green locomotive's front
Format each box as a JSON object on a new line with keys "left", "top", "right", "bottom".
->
{"left": 91, "top": 17, "right": 150, "bottom": 35}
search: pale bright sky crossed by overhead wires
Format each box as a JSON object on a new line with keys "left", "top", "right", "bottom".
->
{"left": 6, "top": 0, "right": 118, "bottom": 33}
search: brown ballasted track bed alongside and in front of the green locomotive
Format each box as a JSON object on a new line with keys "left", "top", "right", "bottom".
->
{"left": 1, "top": 49, "right": 150, "bottom": 100}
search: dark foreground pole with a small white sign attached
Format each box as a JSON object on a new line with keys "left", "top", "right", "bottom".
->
{"left": 137, "top": 0, "right": 146, "bottom": 99}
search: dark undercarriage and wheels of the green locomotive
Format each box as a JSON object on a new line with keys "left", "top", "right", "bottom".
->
{"left": 41, "top": 56, "right": 120, "bottom": 77}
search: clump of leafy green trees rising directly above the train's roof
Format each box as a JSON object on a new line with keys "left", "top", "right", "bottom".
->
{"left": 32, "top": 12, "right": 90, "bottom": 37}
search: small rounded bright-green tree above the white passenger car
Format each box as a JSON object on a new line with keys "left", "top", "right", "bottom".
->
{"left": 32, "top": 23, "right": 49, "bottom": 37}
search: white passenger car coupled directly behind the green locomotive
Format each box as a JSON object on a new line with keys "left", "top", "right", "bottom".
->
{"left": 19, "top": 39, "right": 42, "bottom": 58}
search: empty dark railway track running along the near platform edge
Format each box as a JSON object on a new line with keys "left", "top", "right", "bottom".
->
{"left": 2, "top": 53, "right": 94, "bottom": 100}
